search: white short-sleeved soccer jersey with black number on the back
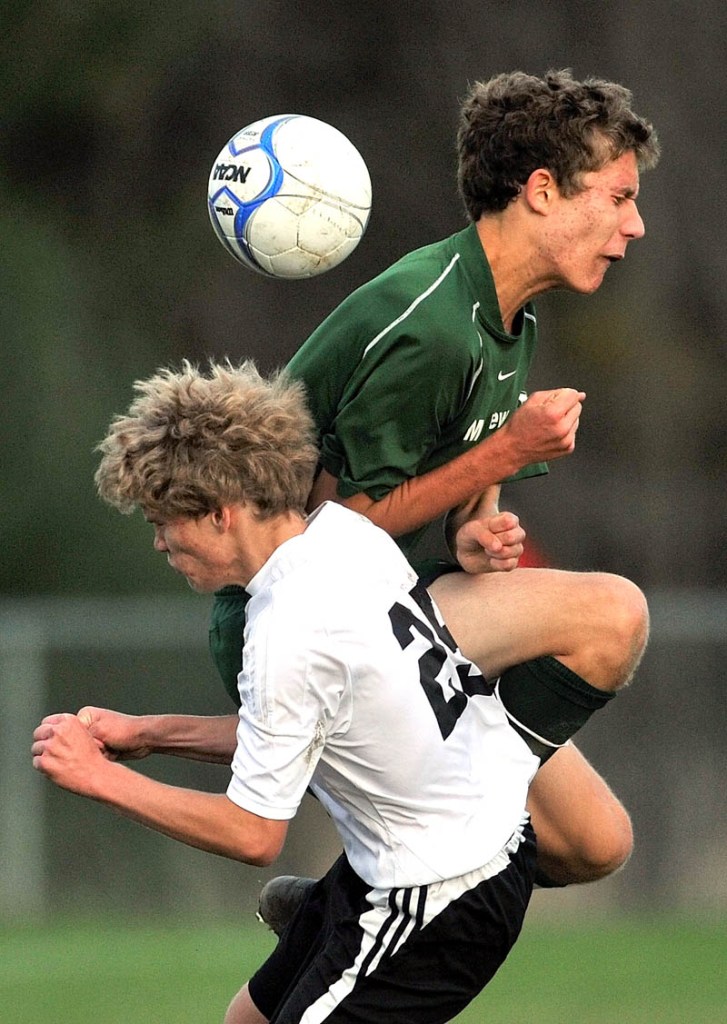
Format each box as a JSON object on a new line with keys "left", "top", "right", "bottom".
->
{"left": 227, "top": 504, "right": 539, "bottom": 888}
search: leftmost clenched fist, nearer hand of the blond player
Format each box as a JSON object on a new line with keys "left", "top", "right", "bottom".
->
{"left": 31, "top": 714, "right": 103, "bottom": 797}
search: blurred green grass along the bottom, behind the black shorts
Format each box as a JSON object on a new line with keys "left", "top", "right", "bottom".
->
{"left": 0, "top": 920, "right": 727, "bottom": 1024}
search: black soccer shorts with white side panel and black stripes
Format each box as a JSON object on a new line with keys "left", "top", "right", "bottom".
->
{"left": 249, "top": 822, "right": 536, "bottom": 1024}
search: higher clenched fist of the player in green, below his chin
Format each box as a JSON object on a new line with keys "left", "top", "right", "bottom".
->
{"left": 501, "top": 387, "right": 586, "bottom": 466}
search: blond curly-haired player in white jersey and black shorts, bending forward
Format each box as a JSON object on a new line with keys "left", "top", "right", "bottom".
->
{"left": 33, "top": 364, "right": 622, "bottom": 1024}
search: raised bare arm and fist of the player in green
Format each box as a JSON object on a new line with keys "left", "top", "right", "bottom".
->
{"left": 308, "top": 388, "right": 586, "bottom": 537}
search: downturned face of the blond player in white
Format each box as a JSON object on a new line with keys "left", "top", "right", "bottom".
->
{"left": 146, "top": 513, "right": 229, "bottom": 594}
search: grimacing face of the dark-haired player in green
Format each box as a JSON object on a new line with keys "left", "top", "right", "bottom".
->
{"left": 546, "top": 153, "right": 644, "bottom": 294}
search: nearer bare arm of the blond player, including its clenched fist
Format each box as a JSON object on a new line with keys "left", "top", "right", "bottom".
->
{"left": 32, "top": 715, "right": 287, "bottom": 866}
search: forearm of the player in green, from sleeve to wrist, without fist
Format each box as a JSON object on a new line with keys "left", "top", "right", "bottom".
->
{"left": 339, "top": 430, "right": 523, "bottom": 537}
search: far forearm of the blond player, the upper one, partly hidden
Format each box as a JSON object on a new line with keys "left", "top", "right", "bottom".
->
{"left": 138, "top": 715, "right": 238, "bottom": 765}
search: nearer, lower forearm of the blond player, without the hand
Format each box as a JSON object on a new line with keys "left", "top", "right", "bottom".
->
{"left": 85, "top": 761, "right": 286, "bottom": 866}
